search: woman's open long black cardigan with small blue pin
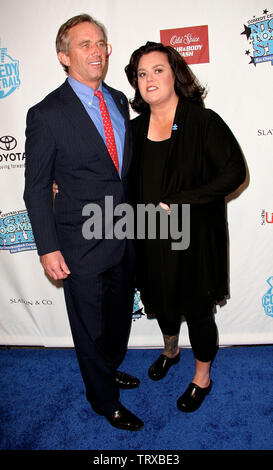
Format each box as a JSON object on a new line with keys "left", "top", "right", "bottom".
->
{"left": 131, "top": 100, "right": 246, "bottom": 301}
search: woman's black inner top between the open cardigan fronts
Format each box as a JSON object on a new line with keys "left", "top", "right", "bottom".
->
{"left": 137, "top": 139, "right": 181, "bottom": 321}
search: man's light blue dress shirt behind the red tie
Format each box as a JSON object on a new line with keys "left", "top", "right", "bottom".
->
{"left": 68, "top": 76, "right": 125, "bottom": 175}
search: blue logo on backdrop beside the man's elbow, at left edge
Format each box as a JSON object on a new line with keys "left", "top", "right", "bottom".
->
{"left": 0, "top": 210, "right": 36, "bottom": 253}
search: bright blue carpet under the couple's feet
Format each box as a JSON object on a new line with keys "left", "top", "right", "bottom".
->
{"left": 0, "top": 345, "right": 273, "bottom": 451}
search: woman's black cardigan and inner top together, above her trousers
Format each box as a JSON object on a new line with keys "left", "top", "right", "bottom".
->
{"left": 130, "top": 100, "right": 246, "bottom": 316}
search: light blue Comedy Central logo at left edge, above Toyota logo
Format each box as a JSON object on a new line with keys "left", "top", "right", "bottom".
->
{"left": 0, "top": 40, "right": 20, "bottom": 98}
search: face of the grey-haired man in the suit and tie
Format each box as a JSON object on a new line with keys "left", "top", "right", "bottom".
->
{"left": 58, "top": 22, "right": 107, "bottom": 89}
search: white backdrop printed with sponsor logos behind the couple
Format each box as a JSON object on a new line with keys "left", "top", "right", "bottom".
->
{"left": 0, "top": 0, "right": 273, "bottom": 347}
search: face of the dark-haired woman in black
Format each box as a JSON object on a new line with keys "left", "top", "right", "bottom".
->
{"left": 137, "top": 51, "right": 176, "bottom": 106}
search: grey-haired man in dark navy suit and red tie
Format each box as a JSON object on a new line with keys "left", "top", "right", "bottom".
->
{"left": 24, "top": 15, "right": 143, "bottom": 430}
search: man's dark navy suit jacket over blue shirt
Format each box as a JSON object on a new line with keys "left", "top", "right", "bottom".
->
{"left": 24, "top": 81, "right": 132, "bottom": 274}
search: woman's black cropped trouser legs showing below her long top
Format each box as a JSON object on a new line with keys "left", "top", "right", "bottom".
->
{"left": 157, "top": 298, "right": 218, "bottom": 362}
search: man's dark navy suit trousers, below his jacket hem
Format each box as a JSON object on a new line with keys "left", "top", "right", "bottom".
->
{"left": 63, "top": 250, "right": 134, "bottom": 415}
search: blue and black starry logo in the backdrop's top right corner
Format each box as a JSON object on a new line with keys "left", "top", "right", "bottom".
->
{"left": 241, "top": 9, "right": 273, "bottom": 67}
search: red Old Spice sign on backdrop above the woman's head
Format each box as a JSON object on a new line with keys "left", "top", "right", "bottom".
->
{"left": 160, "top": 25, "right": 209, "bottom": 64}
